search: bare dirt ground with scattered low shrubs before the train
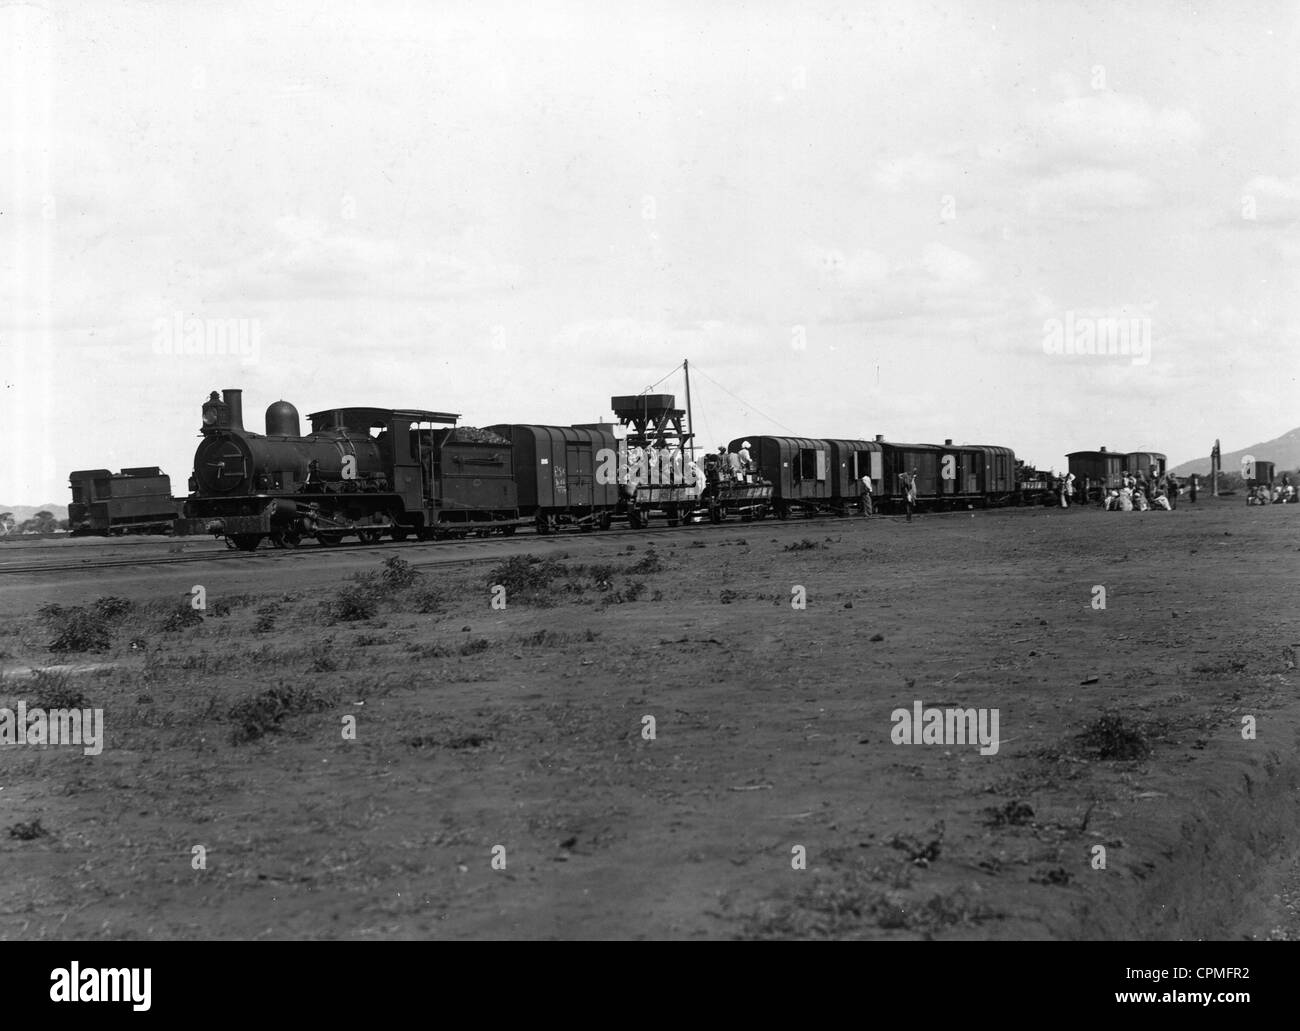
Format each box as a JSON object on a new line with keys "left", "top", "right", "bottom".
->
{"left": 0, "top": 498, "right": 1300, "bottom": 939}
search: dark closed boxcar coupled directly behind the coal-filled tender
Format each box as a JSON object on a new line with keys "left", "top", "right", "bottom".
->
{"left": 488, "top": 424, "right": 619, "bottom": 533}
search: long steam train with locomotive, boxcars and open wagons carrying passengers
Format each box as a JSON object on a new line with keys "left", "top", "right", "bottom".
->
{"left": 176, "top": 387, "right": 1086, "bottom": 550}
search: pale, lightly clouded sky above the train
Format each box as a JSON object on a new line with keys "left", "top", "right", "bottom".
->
{"left": 0, "top": 0, "right": 1300, "bottom": 504}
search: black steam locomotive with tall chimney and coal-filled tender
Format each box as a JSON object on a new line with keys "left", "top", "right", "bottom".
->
{"left": 176, "top": 390, "right": 523, "bottom": 551}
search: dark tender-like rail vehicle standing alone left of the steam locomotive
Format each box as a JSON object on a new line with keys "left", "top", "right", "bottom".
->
{"left": 68, "top": 465, "right": 179, "bottom": 537}
